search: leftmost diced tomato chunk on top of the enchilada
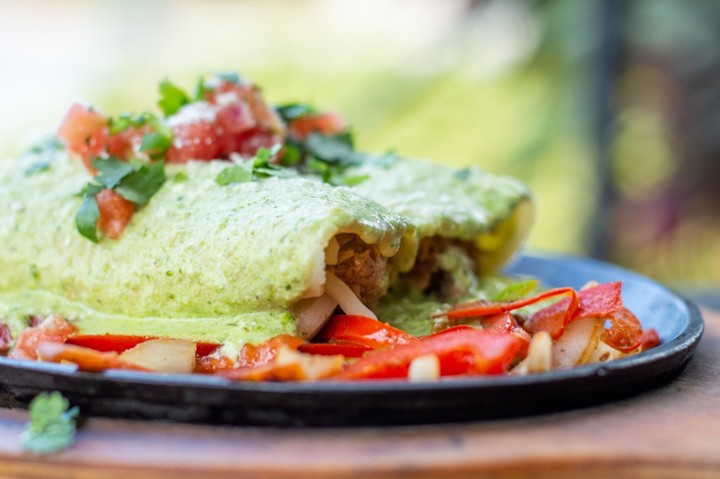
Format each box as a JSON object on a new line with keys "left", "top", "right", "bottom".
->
{"left": 57, "top": 103, "right": 108, "bottom": 173}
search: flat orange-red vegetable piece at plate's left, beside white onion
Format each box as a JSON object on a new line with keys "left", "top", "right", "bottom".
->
{"left": 37, "top": 341, "right": 146, "bottom": 373}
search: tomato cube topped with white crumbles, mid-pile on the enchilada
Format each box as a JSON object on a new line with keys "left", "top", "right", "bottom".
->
{"left": 165, "top": 121, "right": 220, "bottom": 163}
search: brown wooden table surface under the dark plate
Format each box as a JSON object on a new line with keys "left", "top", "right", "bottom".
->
{"left": 0, "top": 310, "right": 720, "bottom": 479}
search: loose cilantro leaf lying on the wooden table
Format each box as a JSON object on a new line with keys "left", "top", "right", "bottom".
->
{"left": 21, "top": 391, "right": 79, "bottom": 454}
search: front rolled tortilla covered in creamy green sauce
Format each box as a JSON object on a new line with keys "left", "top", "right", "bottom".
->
{"left": 0, "top": 153, "right": 412, "bottom": 352}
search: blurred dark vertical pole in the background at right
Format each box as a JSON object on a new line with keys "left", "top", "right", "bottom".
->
{"left": 589, "top": 0, "right": 622, "bottom": 259}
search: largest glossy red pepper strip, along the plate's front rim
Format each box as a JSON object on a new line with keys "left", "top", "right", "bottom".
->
{"left": 335, "top": 329, "right": 518, "bottom": 380}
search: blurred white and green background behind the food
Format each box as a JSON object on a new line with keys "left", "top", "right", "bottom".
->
{"left": 0, "top": 0, "right": 720, "bottom": 296}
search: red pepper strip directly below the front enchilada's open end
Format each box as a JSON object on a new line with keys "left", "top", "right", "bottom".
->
{"left": 315, "top": 314, "right": 417, "bottom": 349}
